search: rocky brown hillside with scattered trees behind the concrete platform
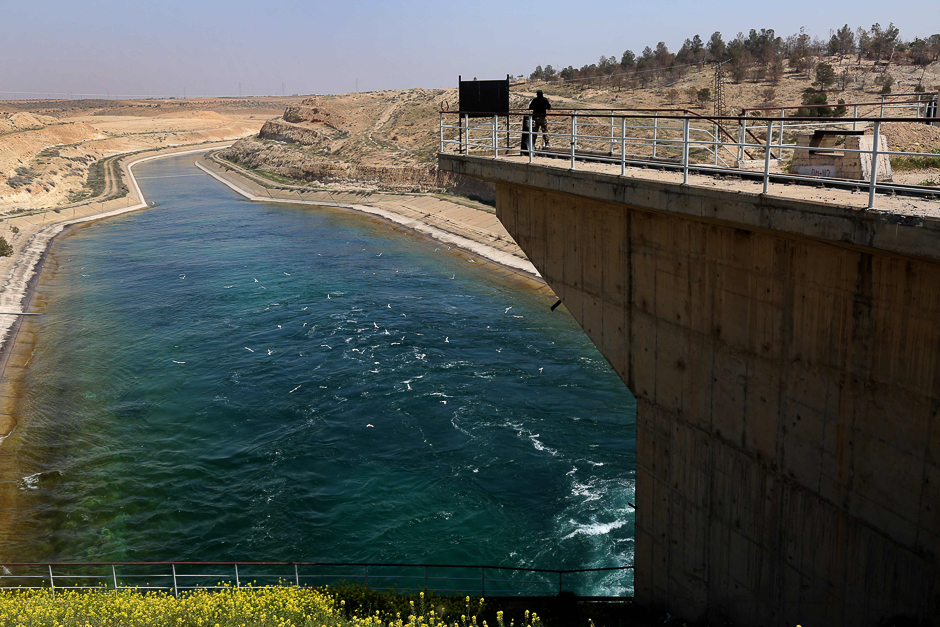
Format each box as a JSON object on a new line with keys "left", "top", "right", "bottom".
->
{"left": 222, "top": 57, "right": 940, "bottom": 197}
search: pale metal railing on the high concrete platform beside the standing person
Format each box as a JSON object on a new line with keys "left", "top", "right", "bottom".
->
{"left": 439, "top": 103, "right": 940, "bottom": 209}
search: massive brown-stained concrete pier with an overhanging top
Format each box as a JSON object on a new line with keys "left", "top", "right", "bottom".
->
{"left": 439, "top": 154, "right": 940, "bottom": 627}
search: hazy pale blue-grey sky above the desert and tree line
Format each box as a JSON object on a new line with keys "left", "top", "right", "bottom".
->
{"left": 0, "top": 0, "right": 940, "bottom": 99}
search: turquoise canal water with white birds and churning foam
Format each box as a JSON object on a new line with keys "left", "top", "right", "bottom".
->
{"left": 5, "top": 157, "right": 635, "bottom": 594}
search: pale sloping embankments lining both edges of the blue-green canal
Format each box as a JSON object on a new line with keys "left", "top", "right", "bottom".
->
{"left": 0, "top": 144, "right": 550, "bottom": 444}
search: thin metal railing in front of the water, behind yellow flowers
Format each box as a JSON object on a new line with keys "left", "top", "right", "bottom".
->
{"left": 0, "top": 562, "right": 633, "bottom": 597}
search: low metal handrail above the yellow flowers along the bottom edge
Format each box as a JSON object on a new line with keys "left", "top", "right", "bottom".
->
{"left": 0, "top": 562, "right": 633, "bottom": 596}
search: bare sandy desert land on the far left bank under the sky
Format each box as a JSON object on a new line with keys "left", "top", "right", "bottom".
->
{"left": 0, "top": 98, "right": 300, "bottom": 217}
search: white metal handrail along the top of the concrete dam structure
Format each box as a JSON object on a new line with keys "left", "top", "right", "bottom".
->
{"left": 440, "top": 109, "right": 940, "bottom": 209}
